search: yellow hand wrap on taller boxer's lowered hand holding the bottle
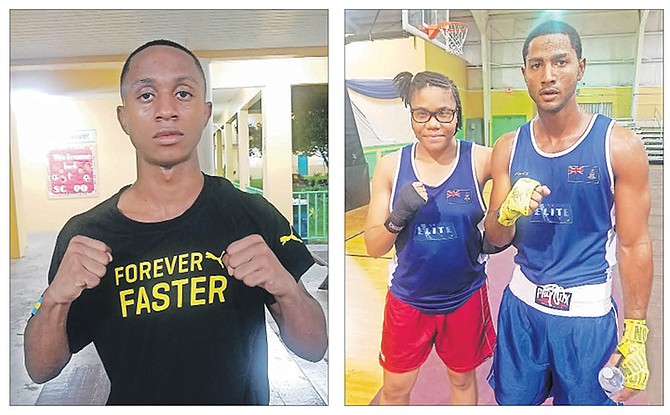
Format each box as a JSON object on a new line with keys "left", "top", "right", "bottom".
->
{"left": 617, "top": 319, "right": 649, "bottom": 390}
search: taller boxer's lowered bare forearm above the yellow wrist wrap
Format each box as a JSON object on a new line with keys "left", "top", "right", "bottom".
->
{"left": 617, "top": 237, "right": 653, "bottom": 320}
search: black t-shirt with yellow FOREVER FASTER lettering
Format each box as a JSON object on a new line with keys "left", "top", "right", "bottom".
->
{"left": 49, "top": 175, "right": 314, "bottom": 404}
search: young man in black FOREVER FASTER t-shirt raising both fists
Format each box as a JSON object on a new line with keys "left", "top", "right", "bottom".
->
{"left": 25, "top": 40, "right": 327, "bottom": 404}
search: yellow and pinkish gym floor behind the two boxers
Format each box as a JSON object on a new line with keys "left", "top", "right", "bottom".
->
{"left": 345, "top": 166, "right": 664, "bottom": 405}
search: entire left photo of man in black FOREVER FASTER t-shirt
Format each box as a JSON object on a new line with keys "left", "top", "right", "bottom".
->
{"left": 9, "top": 9, "right": 329, "bottom": 406}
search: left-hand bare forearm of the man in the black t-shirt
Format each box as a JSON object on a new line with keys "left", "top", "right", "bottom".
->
{"left": 24, "top": 290, "right": 72, "bottom": 383}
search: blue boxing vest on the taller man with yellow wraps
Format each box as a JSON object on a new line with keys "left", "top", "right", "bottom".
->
{"left": 510, "top": 115, "right": 616, "bottom": 288}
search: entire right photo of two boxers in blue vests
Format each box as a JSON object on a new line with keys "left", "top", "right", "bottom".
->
{"left": 344, "top": 9, "right": 664, "bottom": 406}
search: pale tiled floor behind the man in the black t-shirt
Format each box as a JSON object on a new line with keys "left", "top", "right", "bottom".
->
{"left": 9, "top": 233, "right": 328, "bottom": 405}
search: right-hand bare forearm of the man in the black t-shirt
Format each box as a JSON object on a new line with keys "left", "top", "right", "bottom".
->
{"left": 273, "top": 285, "right": 328, "bottom": 362}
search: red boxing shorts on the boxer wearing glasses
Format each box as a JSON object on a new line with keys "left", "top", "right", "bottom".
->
{"left": 379, "top": 284, "right": 496, "bottom": 373}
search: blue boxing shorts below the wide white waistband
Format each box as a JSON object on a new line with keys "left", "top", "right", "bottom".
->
{"left": 489, "top": 286, "right": 617, "bottom": 405}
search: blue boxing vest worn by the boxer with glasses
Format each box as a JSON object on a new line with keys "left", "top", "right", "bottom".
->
{"left": 389, "top": 140, "right": 487, "bottom": 314}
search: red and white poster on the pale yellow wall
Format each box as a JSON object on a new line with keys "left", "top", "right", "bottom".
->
{"left": 47, "top": 132, "right": 97, "bottom": 198}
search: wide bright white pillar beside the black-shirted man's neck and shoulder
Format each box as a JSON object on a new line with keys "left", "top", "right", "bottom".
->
{"left": 261, "top": 82, "right": 293, "bottom": 221}
